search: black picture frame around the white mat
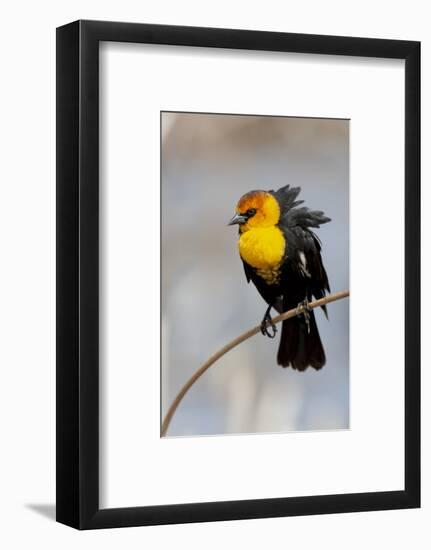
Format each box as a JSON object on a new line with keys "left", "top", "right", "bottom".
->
{"left": 56, "top": 21, "right": 420, "bottom": 529}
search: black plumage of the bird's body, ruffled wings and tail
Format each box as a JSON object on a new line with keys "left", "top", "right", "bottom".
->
{"left": 243, "top": 185, "right": 330, "bottom": 371}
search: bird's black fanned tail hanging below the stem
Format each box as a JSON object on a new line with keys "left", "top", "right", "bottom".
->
{"left": 277, "top": 311, "right": 326, "bottom": 371}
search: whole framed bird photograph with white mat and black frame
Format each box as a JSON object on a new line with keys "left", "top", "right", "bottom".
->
{"left": 57, "top": 21, "right": 420, "bottom": 529}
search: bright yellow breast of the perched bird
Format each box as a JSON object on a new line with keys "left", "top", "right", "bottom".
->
{"left": 238, "top": 226, "right": 285, "bottom": 274}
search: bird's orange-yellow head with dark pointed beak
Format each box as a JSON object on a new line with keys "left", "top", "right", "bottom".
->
{"left": 229, "top": 191, "right": 280, "bottom": 233}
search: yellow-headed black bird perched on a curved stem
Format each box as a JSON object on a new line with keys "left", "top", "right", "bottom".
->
{"left": 228, "top": 185, "right": 331, "bottom": 371}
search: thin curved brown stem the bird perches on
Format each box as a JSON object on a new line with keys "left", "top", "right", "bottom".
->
{"left": 161, "top": 290, "right": 349, "bottom": 437}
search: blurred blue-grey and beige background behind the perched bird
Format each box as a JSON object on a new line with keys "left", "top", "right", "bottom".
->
{"left": 161, "top": 113, "right": 349, "bottom": 436}
